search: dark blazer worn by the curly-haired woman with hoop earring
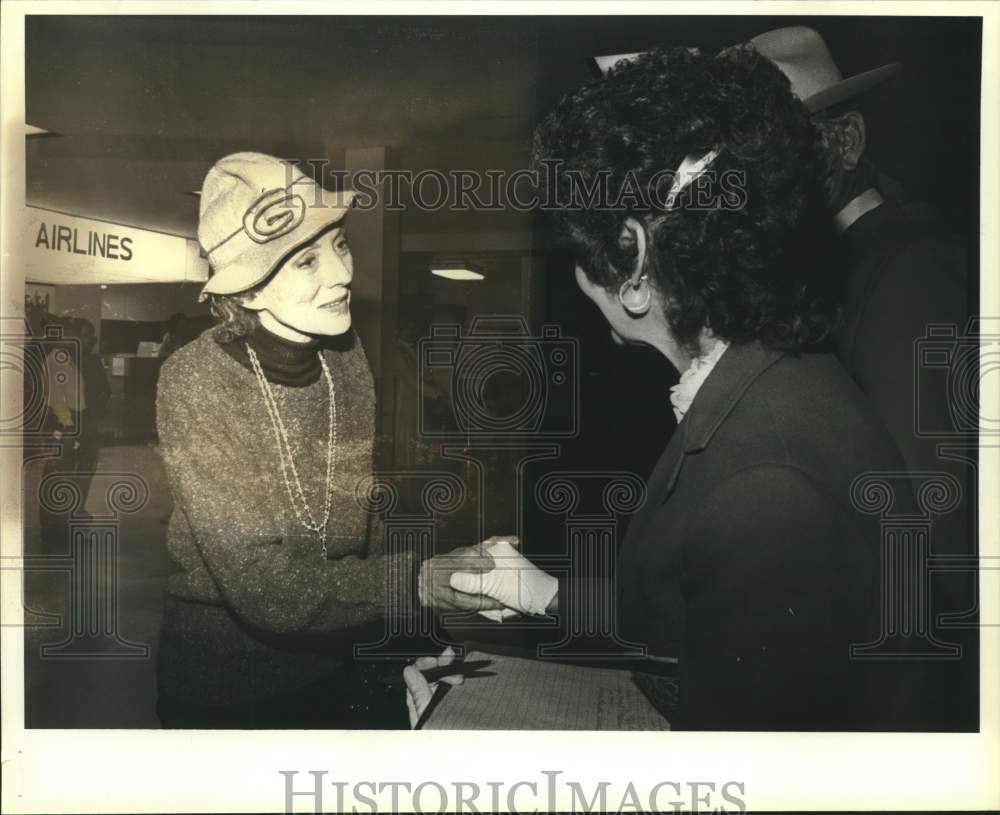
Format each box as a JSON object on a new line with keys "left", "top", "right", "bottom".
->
{"left": 619, "top": 343, "right": 915, "bottom": 730}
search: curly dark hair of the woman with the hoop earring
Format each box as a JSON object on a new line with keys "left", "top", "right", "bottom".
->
{"left": 532, "top": 46, "right": 836, "bottom": 349}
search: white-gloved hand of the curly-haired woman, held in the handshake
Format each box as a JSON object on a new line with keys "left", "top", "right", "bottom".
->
{"left": 450, "top": 538, "right": 559, "bottom": 620}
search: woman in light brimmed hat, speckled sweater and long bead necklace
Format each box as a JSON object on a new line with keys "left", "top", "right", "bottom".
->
{"left": 157, "top": 153, "right": 411, "bottom": 727}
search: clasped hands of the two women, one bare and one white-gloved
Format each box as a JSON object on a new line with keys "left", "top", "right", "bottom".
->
{"left": 418, "top": 535, "right": 559, "bottom": 622}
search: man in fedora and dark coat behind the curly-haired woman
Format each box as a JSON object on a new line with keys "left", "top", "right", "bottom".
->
{"left": 751, "top": 26, "right": 979, "bottom": 728}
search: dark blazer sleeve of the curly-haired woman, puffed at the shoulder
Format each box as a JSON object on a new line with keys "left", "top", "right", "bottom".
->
{"left": 675, "top": 465, "right": 857, "bottom": 730}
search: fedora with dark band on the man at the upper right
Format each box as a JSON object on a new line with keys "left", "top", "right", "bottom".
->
{"left": 594, "top": 26, "right": 903, "bottom": 113}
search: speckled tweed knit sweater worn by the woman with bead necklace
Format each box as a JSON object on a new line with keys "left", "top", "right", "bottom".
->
{"left": 157, "top": 332, "right": 411, "bottom": 705}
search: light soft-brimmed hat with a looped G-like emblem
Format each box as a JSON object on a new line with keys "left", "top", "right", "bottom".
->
{"left": 198, "top": 153, "right": 354, "bottom": 300}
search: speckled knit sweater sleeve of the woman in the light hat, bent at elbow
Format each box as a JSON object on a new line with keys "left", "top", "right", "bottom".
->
{"left": 157, "top": 368, "right": 412, "bottom": 634}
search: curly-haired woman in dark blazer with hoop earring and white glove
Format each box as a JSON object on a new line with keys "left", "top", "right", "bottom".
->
{"left": 420, "top": 47, "right": 912, "bottom": 729}
